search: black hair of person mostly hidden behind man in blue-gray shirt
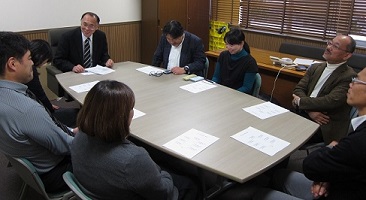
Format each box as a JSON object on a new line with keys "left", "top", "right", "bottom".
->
{"left": 30, "top": 39, "right": 53, "bottom": 67}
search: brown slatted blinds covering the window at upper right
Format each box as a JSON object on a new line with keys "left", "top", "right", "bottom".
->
{"left": 212, "top": 0, "right": 366, "bottom": 40}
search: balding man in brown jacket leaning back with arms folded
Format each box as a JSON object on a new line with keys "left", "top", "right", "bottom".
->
{"left": 292, "top": 35, "right": 356, "bottom": 144}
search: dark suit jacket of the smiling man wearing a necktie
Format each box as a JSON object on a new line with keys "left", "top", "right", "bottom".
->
{"left": 53, "top": 27, "right": 110, "bottom": 72}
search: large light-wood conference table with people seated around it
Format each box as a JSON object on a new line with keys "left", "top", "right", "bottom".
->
{"left": 56, "top": 62, "right": 319, "bottom": 199}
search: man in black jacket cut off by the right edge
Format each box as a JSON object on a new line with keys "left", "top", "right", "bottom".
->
{"left": 254, "top": 68, "right": 366, "bottom": 200}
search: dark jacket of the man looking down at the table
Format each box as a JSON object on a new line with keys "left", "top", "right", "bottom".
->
{"left": 152, "top": 31, "right": 206, "bottom": 76}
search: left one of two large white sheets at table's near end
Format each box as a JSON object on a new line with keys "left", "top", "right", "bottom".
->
{"left": 163, "top": 129, "right": 219, "bottom": 158}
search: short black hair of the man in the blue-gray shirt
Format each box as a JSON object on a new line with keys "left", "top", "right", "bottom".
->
{"left": 0, "top": 31, "right": 30, "bottom": 75}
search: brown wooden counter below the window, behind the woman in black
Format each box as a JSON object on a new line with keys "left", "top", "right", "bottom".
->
{"left": 206, "top": 47, "right": 305, "bottom": 109}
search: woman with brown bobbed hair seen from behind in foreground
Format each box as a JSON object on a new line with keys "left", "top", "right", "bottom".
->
{"left": 71, "top": 80, "right": 178, "bottom": 200}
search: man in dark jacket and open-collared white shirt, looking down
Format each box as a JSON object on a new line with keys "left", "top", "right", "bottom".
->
{"left": 152, "top": 20, "right": 206, "bottom": 76}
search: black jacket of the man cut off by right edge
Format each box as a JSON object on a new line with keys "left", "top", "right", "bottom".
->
{"left": 303, "top": 121, "right": 366, "bottom": 199}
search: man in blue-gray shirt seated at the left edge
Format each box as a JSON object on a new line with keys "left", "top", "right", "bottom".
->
{"left": 0, "top": 32, "right": 77, "bottom": 192}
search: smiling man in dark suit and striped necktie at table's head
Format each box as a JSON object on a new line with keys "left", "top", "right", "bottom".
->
{"left": 53, "top": 12, "right": 114, "bottom": 73}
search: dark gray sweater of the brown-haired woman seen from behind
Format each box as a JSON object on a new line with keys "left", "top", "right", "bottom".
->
{"left": 71, "top": 131, "right": 178, "bottom": 200}
